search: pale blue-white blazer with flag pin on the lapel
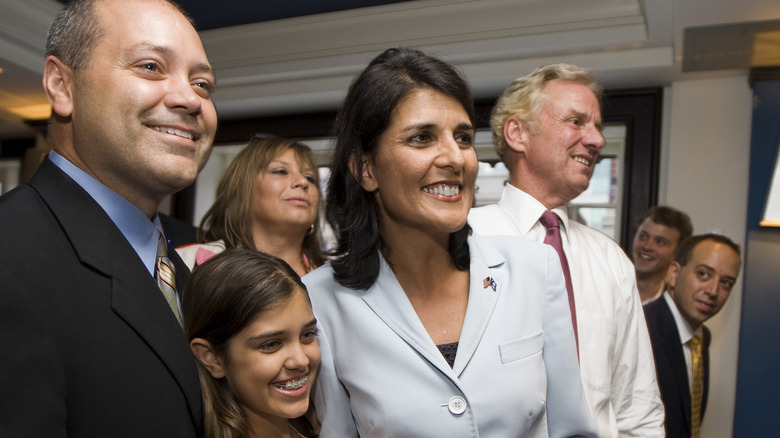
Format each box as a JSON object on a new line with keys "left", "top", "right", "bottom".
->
{"left": 303, "top": 236, "right": 596, "bottom": 438}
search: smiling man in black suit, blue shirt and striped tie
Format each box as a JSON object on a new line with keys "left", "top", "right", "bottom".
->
{"left": 0, "top": 0, "right": 217, "bottom": 438}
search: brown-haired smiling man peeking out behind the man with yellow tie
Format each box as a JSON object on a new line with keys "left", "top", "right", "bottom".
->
{"left": 631, "top": 205, "right": 693, "bottom": 304}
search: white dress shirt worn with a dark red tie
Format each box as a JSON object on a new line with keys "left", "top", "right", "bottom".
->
{"left": 469, "top": 184, "right": 664, "bottom": 438}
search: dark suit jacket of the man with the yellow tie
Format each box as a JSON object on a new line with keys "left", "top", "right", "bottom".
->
{"left": 644, "top": 297, "right": 711, "bottom": 438}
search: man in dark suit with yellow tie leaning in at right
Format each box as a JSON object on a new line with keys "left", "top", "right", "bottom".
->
{"left": 644, "top": 234, "right": 742, "bottom": 438}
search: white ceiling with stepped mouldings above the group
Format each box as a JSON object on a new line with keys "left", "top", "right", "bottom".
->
{"left": 0, "top": 0, "right": 780, "bottom": 140}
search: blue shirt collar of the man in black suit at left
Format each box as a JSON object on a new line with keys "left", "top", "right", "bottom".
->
{"left": 49, "top": 151, "right": 162, "bottom": 275}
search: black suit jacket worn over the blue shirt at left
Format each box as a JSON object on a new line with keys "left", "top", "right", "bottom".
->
{"left": 0, "top": 159, "right": 202, "bottom": 438}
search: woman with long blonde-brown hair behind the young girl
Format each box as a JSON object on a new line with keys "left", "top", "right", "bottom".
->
{"left": 177, "top": 134, "right": 324, "bottom": 276}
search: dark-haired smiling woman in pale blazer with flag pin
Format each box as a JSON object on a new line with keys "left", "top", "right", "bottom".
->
{"left": 304, "top": 49, "right": 596, "bottom": 438}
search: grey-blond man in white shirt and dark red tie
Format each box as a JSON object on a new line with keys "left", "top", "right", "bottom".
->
{"left": 469, "top": 64, "right": 664, "bottom": 438}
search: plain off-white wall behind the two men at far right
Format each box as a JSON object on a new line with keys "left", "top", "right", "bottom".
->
{"left": 658, "top": 74, "right": 752, "bottom": 438}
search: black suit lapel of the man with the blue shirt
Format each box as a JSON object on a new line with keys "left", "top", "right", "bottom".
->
{"left": 30, "top": 159, "right": 202, "bottom": 427}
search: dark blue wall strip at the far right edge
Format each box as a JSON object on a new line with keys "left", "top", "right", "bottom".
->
{"left": 734, "top": 80, "right": 780, "bottom": 437}
